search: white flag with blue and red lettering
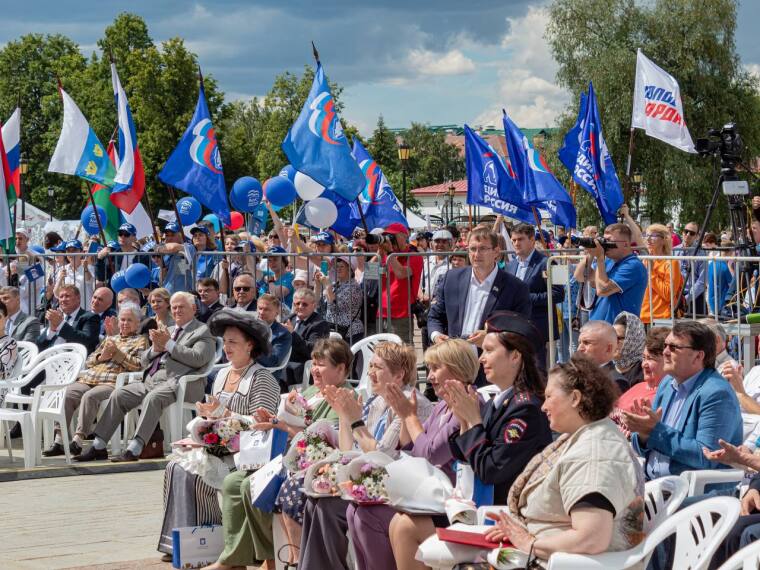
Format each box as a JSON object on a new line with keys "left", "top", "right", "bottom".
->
{"left": 631, "top": 49, "right": 696, "bottom": 152}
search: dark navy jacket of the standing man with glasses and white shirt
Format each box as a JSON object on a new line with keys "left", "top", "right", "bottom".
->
{"left": 428, "top": 267, "right": 528, "bottom": 338}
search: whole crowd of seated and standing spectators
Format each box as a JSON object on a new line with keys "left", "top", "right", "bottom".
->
{"left": 0, "top": 193, "right": 760, "bottom": 570}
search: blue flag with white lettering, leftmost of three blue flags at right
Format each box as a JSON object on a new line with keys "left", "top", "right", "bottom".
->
{"left": 464, "top": 125, "right": 535, "bottom": 224}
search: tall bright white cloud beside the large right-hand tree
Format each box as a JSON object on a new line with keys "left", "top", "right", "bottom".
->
{"left": 473, "top": 7, "right": 568, "bottom": 128}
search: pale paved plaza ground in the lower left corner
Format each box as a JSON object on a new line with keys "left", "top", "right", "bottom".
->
{"left": 0, "top": 466, "right": 172, "bottom": 570}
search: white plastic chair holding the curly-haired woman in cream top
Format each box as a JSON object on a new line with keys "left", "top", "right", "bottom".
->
{"left": 548, "top": 497, "right": 741, "bottom": 570}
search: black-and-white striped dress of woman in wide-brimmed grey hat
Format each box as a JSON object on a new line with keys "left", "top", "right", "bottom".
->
{"left": 158, "top": 364, "right": 280, "bottom": 554}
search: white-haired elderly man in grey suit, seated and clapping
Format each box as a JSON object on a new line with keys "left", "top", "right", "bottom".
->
{"left": 75, "top": 291, "right": 216, "bottom": 461}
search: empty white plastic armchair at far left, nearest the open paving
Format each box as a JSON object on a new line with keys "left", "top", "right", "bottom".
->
{"left": 0, "top": 352, "right": 83, "bottom": 467}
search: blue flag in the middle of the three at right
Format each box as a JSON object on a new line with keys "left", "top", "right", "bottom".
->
{"left": 503, "top": 111, "right": 576, "bottom": 228}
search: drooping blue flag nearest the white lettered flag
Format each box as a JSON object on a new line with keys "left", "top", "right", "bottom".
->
{"left": 573, "top": 83, "right": 623, "bottom": 224}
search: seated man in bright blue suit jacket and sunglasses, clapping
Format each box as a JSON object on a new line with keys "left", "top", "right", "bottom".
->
{"left": 623, "top": 321, "right": 742, "bottom": 479}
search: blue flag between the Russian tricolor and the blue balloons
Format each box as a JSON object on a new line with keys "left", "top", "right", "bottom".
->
{"left": 158, "top": 80, "right": 231, "bottom": 225}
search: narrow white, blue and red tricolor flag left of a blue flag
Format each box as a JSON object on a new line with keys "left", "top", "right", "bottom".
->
{"left": 111, "top": 63, "right": 145, "bottom": 214}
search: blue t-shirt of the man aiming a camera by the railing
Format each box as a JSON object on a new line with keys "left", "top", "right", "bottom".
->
{"left": 589, "top": 253, "right": 647, "bottom": 324}
